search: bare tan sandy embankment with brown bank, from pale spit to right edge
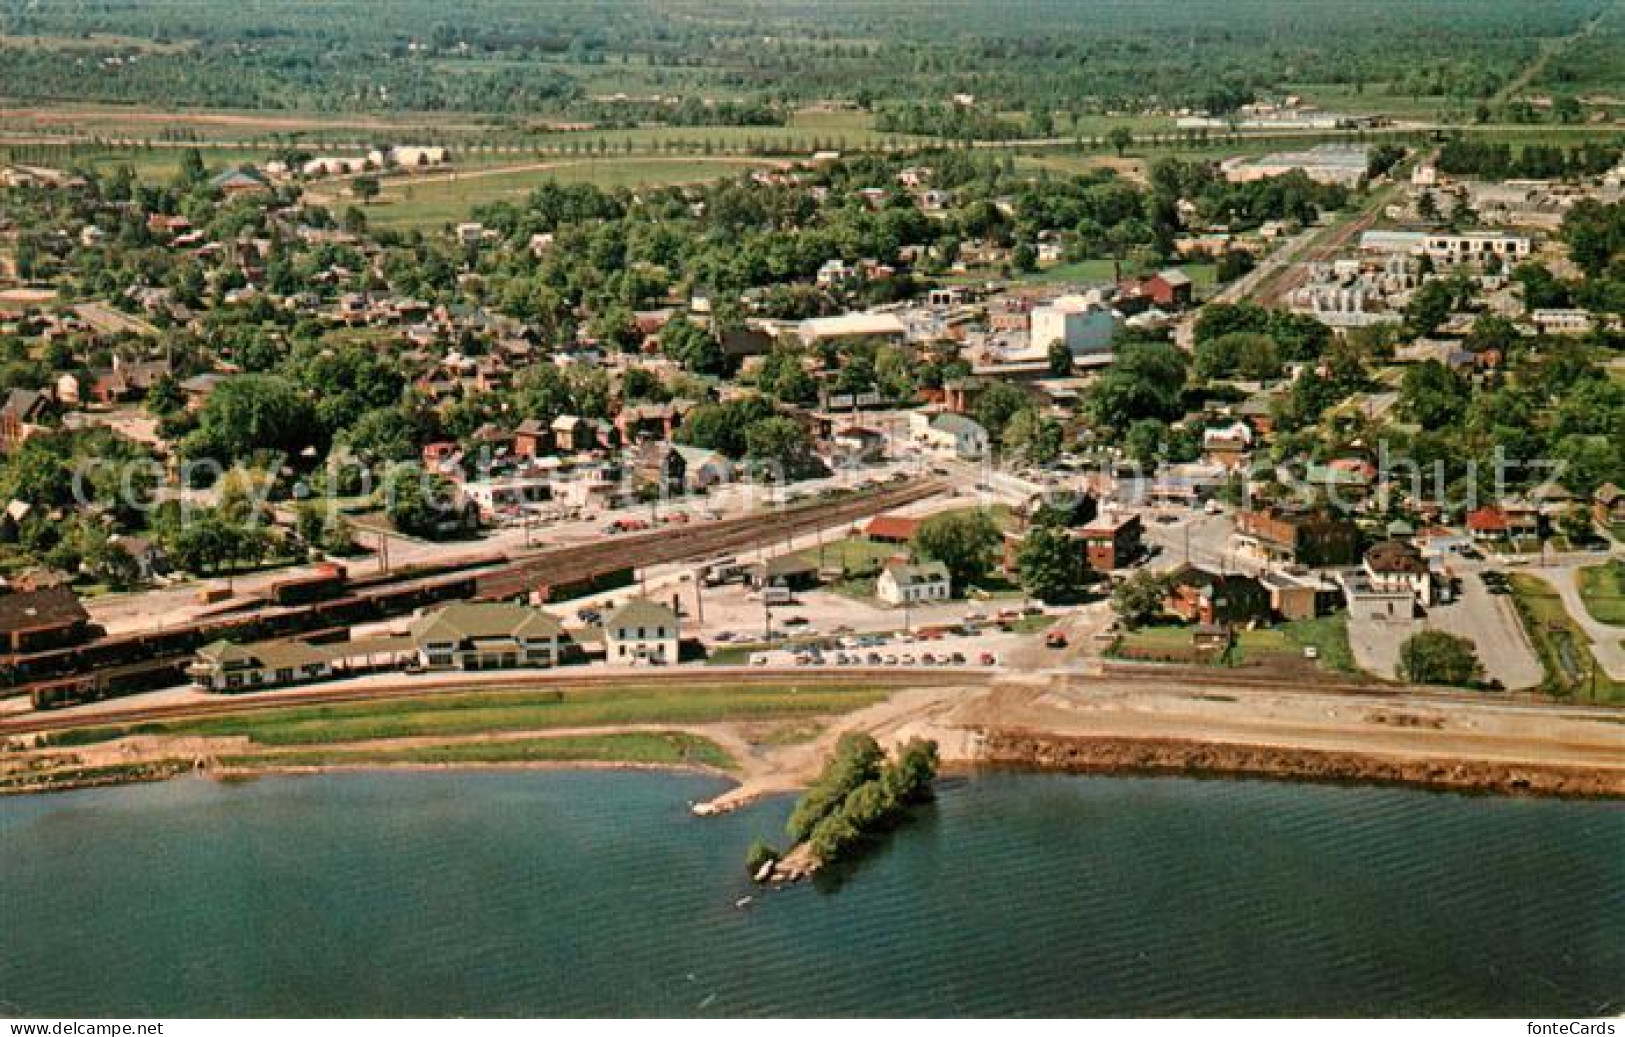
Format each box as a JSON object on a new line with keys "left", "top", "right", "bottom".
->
{"left": 700, "top": 678, "right": 1625, "bottom": 813}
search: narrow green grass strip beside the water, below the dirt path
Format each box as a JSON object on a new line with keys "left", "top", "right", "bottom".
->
{"left": 212, "top": 731, "right": 735, "bottom": 770}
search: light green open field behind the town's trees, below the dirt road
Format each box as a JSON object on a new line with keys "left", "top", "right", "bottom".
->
{"left": 362, "top": 156, "right": 765, "bottom": 228}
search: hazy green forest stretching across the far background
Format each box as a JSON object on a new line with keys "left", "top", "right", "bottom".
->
{"left": 0, "top": 0, "right": 1622, "bottom": 115}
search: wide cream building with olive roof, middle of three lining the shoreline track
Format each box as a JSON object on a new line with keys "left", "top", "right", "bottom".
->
{"left": 411, "top": 601, "right": 564, "bottom": 670}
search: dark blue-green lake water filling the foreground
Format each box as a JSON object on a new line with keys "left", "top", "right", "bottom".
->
{"left": 0, "top": 770, "right": 1625, "bottom": 1016}
